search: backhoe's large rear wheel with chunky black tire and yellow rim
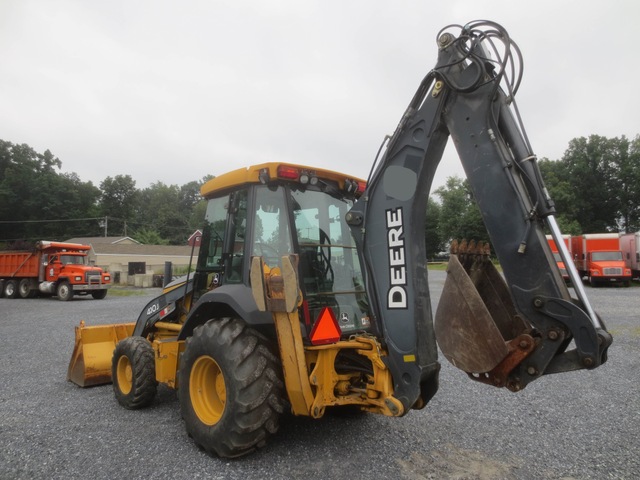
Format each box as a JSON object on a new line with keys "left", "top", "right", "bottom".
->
{"left": 178, "top": 318, "right": 284, "bottom": 457}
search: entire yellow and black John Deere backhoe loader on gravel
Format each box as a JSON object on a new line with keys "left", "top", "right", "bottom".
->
{"left": 68, "top": 21, "right": 612, "bottom": 457}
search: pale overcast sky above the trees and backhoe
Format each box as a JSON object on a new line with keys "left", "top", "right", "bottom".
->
{"left": 0, "top": 0, "right": 640, "bottom": 188}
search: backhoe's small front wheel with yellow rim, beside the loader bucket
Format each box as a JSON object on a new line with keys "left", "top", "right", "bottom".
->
{"left": 111, "top": 337, "right": 158, "bottom": 410}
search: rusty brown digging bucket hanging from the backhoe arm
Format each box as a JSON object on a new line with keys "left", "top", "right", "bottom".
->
{"left": 434, "top": 242, "right": 535, "bottom": 386}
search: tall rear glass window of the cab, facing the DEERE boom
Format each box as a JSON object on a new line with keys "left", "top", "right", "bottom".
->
{"left": 291, "top": 186, "right": 369, "bottom": 333}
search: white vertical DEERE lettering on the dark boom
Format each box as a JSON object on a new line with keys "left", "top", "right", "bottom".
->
{"left": 386, "top": 207, "right": 407, "bottom": 309}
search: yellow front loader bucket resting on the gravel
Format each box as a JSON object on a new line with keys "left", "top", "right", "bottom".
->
{"left": 67, "top": 321, "right": 135, "bottom": 387}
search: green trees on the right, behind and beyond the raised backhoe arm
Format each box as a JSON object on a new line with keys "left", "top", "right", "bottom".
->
{"left": 426, "top": 135, "right": 640, "bottom": 257}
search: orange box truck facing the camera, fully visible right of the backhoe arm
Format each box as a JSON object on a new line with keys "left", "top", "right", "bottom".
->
{"left": 571, "top": 233, "right": 631, "bottom": 287}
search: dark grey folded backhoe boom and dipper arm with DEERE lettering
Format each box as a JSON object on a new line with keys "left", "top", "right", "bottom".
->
{"left": 347, "top": 21, "right": 611, "bottom": 411}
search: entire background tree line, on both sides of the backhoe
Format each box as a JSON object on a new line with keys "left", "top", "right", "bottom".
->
{"left": 0, "top": 135, "right": 640, "bottom": 253}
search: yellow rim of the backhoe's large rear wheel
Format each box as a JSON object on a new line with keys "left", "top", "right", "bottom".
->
{"left": 189, "top": 356, "right": 227, "bottom": 425}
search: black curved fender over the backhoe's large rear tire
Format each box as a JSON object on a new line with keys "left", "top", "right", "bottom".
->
{"left": 178, "top": 284, "right": 275, "bottom": 340}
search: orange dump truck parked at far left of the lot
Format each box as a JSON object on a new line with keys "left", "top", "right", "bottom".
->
{"left": 0, "top": 241, "right": 111, "bottom": 301}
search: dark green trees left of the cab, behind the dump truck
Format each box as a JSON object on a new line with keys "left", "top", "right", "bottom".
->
{"left": 0, "top": 140, "right": 211, "bottom": 247}
